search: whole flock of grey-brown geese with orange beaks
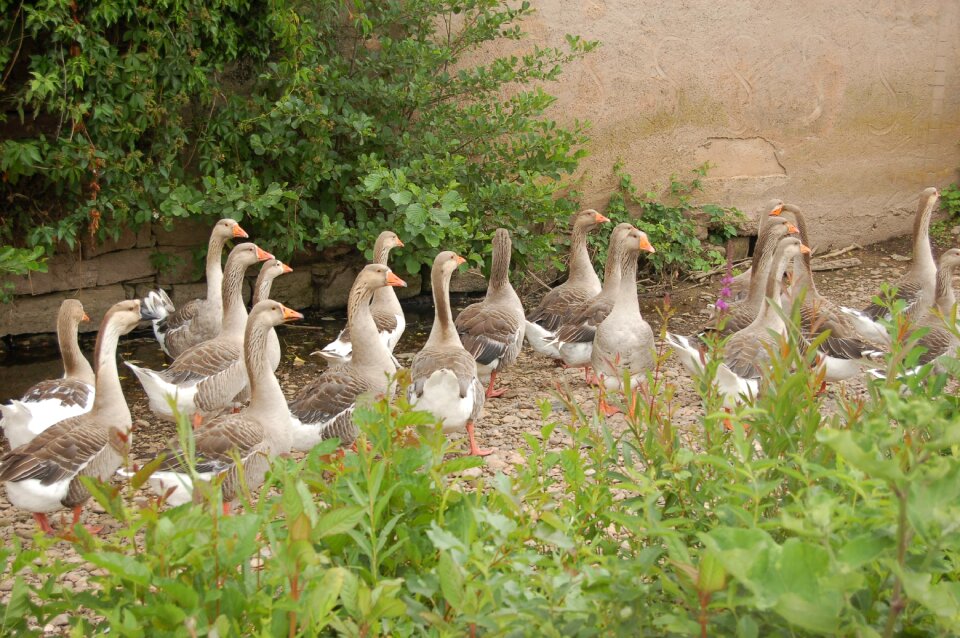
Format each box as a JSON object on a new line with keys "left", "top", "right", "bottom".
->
{"left": 0, "top": 188, "right": 960, "bottom": 533}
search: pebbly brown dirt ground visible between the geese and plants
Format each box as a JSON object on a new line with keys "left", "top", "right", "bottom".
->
{"left": 0, "top": 230, "right": 948, "bottom": 633}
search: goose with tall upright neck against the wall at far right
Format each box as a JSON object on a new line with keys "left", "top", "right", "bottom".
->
{"left": 861, "top": 187, "right": 940, "bottom": 320}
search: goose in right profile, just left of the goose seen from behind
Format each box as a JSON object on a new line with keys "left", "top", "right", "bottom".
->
{"left": 287, "top": 264, "right": 407, "bottom": 451}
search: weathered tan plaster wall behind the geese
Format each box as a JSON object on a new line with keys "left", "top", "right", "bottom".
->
{"left": 518, "top": 0, "right": 960, "bottom": 249}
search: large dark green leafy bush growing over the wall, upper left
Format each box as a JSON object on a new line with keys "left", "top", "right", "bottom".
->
{"left": 0, "top": 0, "right": 596, "bottom": 271}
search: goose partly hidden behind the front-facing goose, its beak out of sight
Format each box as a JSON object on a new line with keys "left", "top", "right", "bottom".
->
{"left": 554, "top": 223, "right": 634, "bottom": 382}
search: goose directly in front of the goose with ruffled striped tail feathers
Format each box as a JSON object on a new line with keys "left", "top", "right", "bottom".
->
{"left": 126, "top": 243, "right": 273, "bottom": 421}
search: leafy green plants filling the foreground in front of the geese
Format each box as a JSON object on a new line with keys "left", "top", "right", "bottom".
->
{"left": 7, "top": 313, "right": 960, "bottom": 637}
